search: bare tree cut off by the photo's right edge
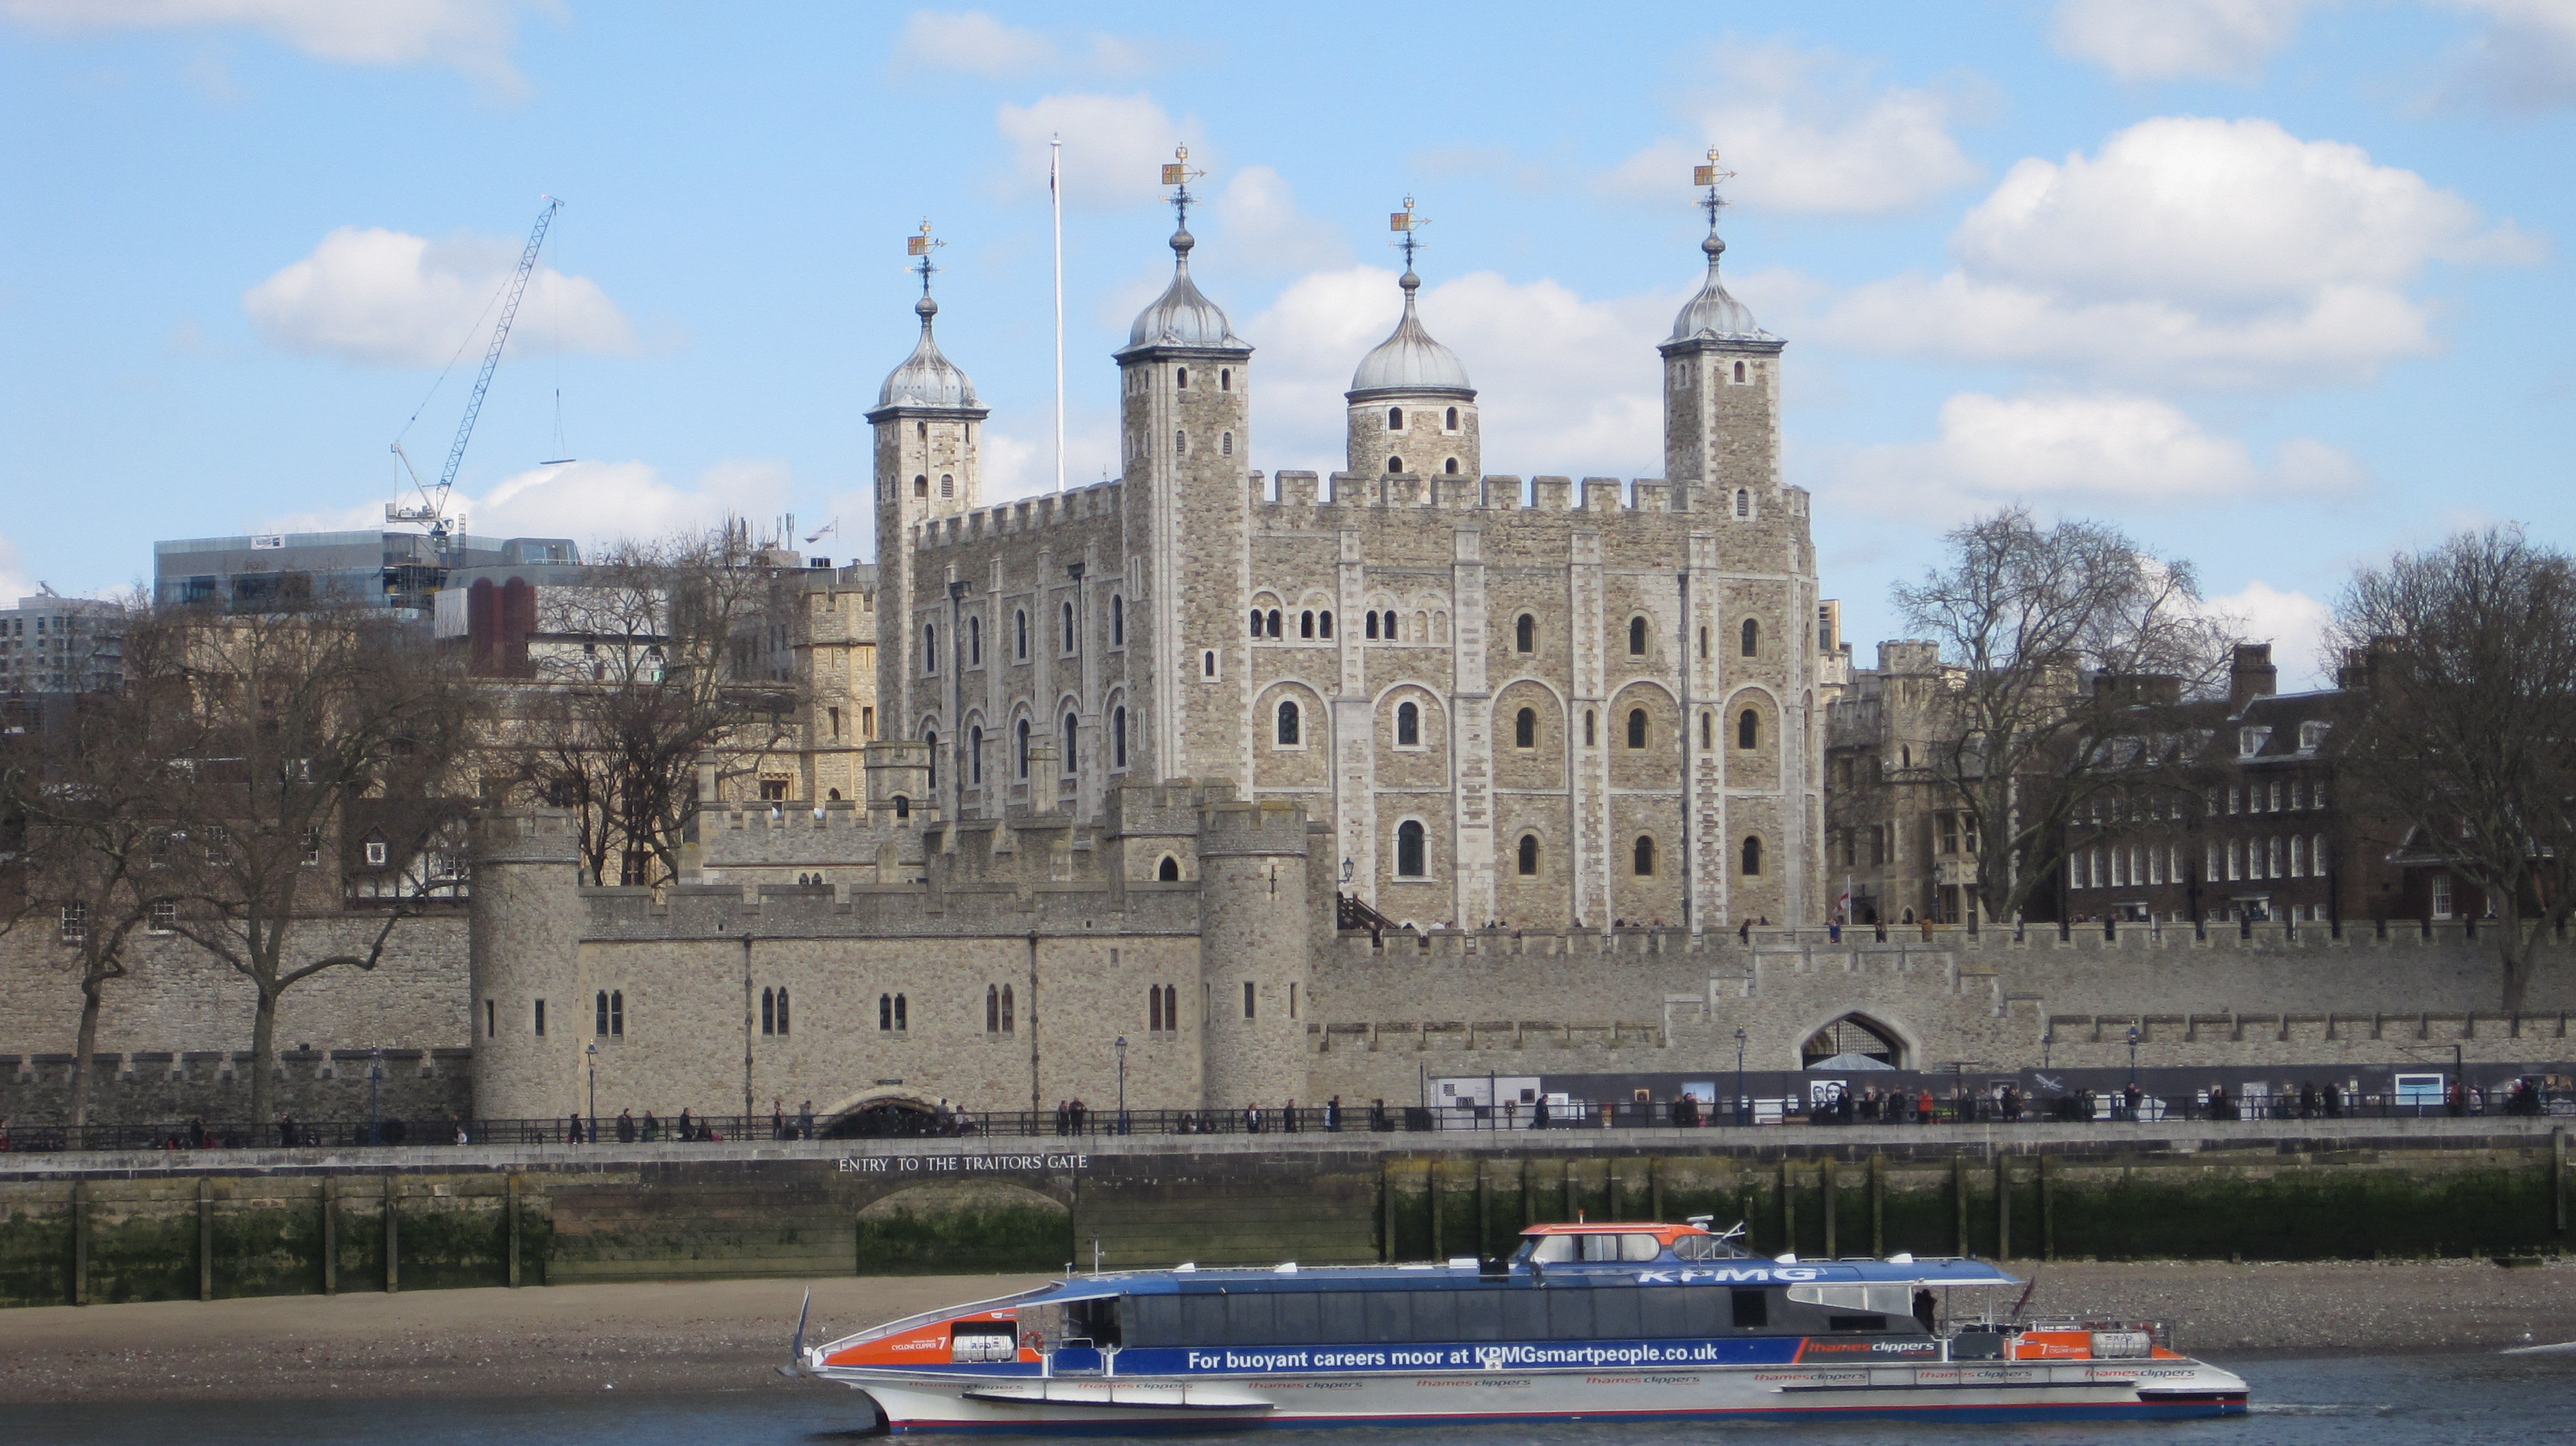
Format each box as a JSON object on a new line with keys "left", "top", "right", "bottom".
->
{"left": 2331, "top": 528, "right": 2576, "bottom": 1010}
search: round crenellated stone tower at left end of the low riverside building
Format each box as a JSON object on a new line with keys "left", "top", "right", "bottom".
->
{"left": 466, "top": 809, "right": 592, "bottom": 1118}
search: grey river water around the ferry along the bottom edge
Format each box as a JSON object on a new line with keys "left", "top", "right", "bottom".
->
{"left": 20, "top": 1354, "right": 2576, "bottom": 1446}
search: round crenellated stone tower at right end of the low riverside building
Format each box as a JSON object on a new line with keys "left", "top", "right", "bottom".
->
{"left": 1198, "top": 801, "right": 1313, "bottom": 1109}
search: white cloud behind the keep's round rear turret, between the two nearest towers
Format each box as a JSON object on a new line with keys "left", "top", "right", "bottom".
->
{"left": 1236, "top": 265, "right": 1682, "bottom": 477}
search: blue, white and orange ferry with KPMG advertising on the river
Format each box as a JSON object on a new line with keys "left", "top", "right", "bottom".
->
{"left": 796, "top": 1221, "right": 2246, "bottom": 1433}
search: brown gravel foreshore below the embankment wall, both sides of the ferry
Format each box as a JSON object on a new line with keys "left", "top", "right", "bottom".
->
{"left": 0, "top": 1260, "right": 2576, "bottom": 1402}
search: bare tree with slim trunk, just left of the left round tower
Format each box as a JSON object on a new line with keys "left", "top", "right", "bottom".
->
{"left": 154, "top": 601, "right": 474, "bottom": 1124}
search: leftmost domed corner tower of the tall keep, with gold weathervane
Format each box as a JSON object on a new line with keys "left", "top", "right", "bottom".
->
{"left": 868, "top": 258, "right": 986, "bottom": 786}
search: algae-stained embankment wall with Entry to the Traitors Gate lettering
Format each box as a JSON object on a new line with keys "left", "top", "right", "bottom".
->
{"left": 0, "top": 1118, "right": 2568, "bottom": 1307}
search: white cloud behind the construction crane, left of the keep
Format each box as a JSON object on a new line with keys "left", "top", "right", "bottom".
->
{"left": 242, "top": 227, "right": 633, "bottom": 366}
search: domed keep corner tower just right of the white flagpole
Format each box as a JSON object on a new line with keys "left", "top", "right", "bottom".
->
{"left": 1116, "top": 188, "right": 1252, "bottom": 789}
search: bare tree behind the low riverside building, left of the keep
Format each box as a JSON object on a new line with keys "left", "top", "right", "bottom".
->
{"left": 500, "top": 526, "right": 791, "bottom": 884}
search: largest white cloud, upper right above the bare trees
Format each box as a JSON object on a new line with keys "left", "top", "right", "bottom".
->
{"left": 1824, "top": 116, "right": 2540, "bottom": 387}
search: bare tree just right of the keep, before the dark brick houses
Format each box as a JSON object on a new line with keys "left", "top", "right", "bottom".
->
{"left": 1893, "top": 508, "right": 2229, "bottom": 920}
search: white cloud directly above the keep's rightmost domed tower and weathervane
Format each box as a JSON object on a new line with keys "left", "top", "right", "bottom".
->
{"left": 1605, "top": 44, "right": 1979, "bottom": 214}
